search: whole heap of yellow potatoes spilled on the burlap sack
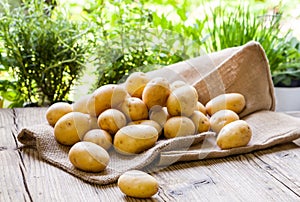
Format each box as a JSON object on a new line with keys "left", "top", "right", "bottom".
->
{"left": 46, "top": 72, "right": 252, "bottom": 199}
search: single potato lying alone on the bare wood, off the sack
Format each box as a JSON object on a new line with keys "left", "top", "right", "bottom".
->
{"left": 118, "top": 170, "right": 159, "bottom": 198}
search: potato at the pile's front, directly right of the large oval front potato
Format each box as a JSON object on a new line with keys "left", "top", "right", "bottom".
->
{"left": 164, "top": 116, "right": 195, "bottom": 138}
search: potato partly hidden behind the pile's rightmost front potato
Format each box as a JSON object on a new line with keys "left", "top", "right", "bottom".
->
{"left": 209, "top": 109, "right": 240, "bottom": 133}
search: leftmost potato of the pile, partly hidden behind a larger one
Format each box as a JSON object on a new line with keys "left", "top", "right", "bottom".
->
{"left": 46, "top": 102, "right": 73, "bottom": 126}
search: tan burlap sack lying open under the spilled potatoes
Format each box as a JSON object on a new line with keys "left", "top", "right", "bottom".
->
{"left": 18, "top": 42, "right": 300, "bottom": 184}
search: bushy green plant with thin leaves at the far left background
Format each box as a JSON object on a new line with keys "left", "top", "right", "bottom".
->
{"left": 0, "top": 0, "right": 85, "bottom": 106}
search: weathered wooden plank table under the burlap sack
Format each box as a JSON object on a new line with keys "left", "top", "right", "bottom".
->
{"left": 0, "top": 108, "right": 300, "bottom": 202}
